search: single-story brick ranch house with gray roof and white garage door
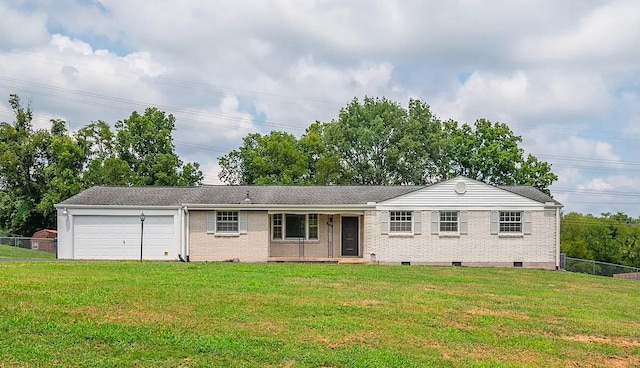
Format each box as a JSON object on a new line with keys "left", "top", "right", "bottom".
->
{"left": 56, "top": 176, "right": 562, "bottom": 269}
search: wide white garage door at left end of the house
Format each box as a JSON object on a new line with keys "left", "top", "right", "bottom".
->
{"left": 73, "top": 216, "right": 178, "bottom": 260}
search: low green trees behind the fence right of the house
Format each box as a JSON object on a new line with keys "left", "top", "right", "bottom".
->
{"left": 560, "top": 212, "right": 640, "bottom": 267}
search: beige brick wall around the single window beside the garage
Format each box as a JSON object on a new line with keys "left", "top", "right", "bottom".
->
{"left": 189, "top": 211, "right": 269, "bottom": 262}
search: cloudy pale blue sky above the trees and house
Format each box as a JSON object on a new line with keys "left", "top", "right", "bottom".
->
{"left": 0, "top": 0, "right": 640, "bottom": 217}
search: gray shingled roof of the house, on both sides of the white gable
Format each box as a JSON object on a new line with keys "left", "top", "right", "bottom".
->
{"left": 59, "top": 185, "right": 560, "bottom": 206}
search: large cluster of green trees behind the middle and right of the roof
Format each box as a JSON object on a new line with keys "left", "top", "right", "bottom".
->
{"left": 218, "top": 97, "right": 558, "bottom": 193}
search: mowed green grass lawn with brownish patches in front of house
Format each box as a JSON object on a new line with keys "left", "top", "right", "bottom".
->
{"left": 0, "top": 262, "right": 640, "bottom": 368}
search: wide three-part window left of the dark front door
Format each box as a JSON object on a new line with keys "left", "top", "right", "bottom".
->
{"left": 271, "top": 213, "right": 319, "bottom": 240}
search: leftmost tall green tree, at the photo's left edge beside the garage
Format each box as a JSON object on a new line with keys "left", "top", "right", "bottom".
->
{"left": 0, "top": 95, "right": 85, "bottom": 235}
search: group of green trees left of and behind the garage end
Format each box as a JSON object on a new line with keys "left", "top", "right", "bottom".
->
{"left": 0, "top": 94, "right": 203, "bottom": 235}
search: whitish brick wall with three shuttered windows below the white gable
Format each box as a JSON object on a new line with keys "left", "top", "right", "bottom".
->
{"left": 364, "top": 210, "right": 556, "bottom": 269}
